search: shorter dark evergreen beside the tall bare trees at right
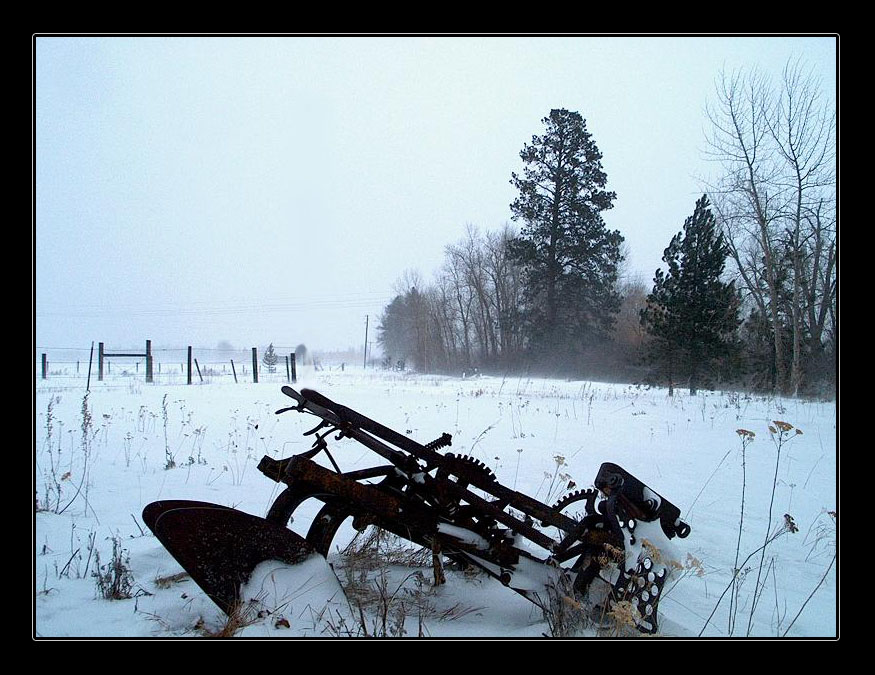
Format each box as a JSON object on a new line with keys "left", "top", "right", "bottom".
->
{"left": 641, "top": 195, "right": 739, "bottom": 394}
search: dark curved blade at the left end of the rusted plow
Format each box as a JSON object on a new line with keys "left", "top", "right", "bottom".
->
{"left": 143, "top": 500, "right": 315, "bottom": 615}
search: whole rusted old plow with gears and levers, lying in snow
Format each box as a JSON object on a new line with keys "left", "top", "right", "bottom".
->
{"left": 143, "top": 387, "right": 690, "bottom": 633}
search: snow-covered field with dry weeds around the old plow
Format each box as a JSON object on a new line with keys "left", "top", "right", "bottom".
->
{"left": 33, "top": 368, "right": 839, "bottom": 638}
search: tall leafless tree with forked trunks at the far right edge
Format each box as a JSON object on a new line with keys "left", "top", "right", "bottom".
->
{"left": 706, "top": 61, "right": 836, "bottom": 393}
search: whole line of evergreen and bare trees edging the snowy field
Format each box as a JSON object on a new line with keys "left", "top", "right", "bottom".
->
{"left": 378, "top": 63, "right": 838, "bottom": 394}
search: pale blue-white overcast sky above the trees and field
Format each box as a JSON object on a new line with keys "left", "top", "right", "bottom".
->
{"left": 32, "top": 35, "right": 838, "bottom": 352}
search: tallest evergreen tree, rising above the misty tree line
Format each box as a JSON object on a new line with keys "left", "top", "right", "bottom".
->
{"left": 511, "top": 110, "right": 623, "bottom": 370}
